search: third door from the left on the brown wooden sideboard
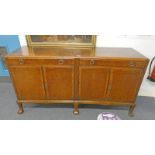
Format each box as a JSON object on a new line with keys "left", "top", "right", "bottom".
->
{"left": 79, "top": 66, "right": 110, "bottom": 100}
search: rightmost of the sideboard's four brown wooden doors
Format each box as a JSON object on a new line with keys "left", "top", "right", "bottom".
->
{"left": 108, "top": 68, "right": 142, "bottom": 102}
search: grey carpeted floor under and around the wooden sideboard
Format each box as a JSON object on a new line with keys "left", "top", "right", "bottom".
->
{"left": 0, "top": 82, "right": 155, "bottom": 120}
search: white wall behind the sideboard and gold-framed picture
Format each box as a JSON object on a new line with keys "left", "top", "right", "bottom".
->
{"left": 19, "top": 35, "right": 155, "bottom": 97}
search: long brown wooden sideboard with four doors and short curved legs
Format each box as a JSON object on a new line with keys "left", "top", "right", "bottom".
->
{"left": 5, "top": 46, "right": 149, "bottom": 116}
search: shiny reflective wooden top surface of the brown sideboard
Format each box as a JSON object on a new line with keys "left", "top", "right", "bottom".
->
{"left": 6, "top": 46, "right": 147, "bottom": 59}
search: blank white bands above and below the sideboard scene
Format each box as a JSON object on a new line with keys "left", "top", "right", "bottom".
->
{"left": 0, "top": 0, "right": 155, "bottom": 155}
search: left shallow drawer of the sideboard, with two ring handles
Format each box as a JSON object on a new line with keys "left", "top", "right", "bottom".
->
{"left": 5, "top": 58, "right": 74, "bottom": 66}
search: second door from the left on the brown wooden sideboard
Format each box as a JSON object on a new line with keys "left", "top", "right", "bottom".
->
{"left": 43, "top": 66, "right": 74, "bottom": 100}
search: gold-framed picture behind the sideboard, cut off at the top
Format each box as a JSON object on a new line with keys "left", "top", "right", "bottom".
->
{"left": 26, "top": 35, "right": 96, "bottom": 47}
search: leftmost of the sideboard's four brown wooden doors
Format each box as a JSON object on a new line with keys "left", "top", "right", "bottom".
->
{"left": 10, "top": 66, "right": 45, "bottom": 100}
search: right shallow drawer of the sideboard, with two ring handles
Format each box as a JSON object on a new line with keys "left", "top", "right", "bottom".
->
{"left": 80, "top": 59, "right": 146, "bottom": 68}
